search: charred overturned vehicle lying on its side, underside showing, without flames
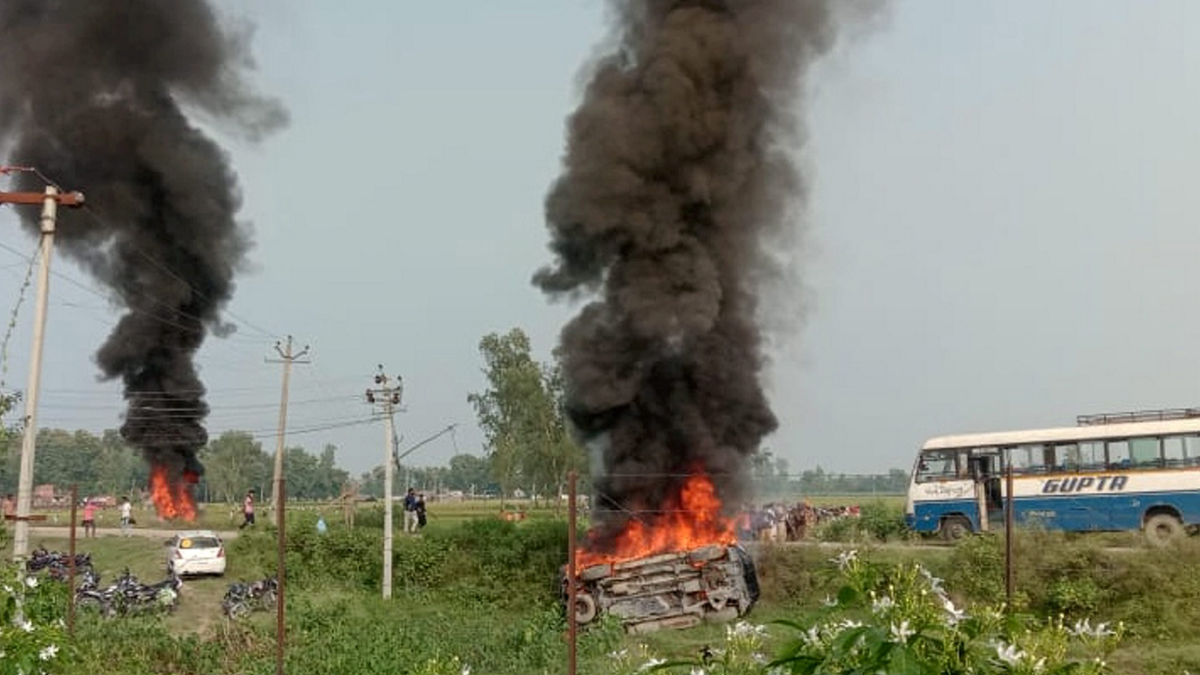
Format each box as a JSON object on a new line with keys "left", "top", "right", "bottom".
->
{"left": 563, "top": 544, "right": 758, "bottom": 633}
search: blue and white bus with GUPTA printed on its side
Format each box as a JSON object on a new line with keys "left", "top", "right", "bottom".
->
{"left": 905, "top": 408, "right": 1200, "bottom": 544}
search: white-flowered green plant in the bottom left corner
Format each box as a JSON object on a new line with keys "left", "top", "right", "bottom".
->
{"left": 0, "top": 566, "right": 65, "bottom": 675}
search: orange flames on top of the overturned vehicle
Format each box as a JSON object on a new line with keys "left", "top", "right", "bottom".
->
{"left": 575, "top": 473, "right": 737, "bottom": 573}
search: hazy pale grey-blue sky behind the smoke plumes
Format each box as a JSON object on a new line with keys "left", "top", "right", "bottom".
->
{"left": 0, "top": 0, "right": 1200, "bottom": 472}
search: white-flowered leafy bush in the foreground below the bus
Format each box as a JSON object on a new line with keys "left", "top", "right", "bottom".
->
{"left": 768, "top": 551, "right": 1122, "bottom": 675}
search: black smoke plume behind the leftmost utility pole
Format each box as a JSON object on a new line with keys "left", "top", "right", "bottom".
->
{"left": 0, "top": 0, "right": 286, "bottom": 494}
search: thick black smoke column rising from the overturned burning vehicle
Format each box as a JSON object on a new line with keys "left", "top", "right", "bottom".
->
{"left": 534, "top": 0, "right": 835, "bottom": 540}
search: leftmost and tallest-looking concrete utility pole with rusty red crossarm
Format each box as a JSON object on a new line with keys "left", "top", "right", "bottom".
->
{"left": 0, "top": 177, "right": 84, "bottom": 563}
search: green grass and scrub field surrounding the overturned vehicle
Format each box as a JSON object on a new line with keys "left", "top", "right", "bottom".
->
{"left": 9, "top": 497, "right": 1200, "bottom": 675}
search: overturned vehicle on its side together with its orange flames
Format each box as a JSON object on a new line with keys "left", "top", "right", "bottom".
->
{"left": 562, "top": 473, "right": 758, "bottom": 633}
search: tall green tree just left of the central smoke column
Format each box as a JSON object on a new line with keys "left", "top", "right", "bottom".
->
{"left": 467, "top": 328, "right": 583, "bottom": 498}
